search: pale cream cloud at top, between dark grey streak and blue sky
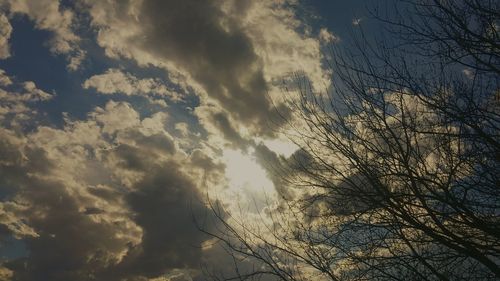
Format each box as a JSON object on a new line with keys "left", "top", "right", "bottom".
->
{"left": 234, "top": 1, "right": 333, "bottom": 92}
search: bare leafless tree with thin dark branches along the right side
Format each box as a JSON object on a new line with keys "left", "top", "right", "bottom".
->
{"left": 202, "top": 0, "right": 500, "bottom": 280}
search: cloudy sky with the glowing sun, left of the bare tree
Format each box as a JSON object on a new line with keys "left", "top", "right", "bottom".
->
{"left": 0, "top": 0, "right": 377, "bottom": 281}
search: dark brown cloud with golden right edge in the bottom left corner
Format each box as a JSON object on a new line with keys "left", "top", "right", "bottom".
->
{"left": 0, "top": 135, "right": 127, "bottom": 281}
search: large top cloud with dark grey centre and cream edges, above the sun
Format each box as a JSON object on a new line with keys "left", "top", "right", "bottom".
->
{"left": 84, "top": 0, "right": 328, "bottom": 142}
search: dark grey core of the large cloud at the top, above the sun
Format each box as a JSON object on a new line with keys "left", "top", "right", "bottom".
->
{"left": 137, "top": 0, "right": 288, "bottom": 134}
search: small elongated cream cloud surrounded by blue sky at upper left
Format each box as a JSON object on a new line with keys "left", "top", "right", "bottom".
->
{"left": 82, "top": 69, "right": 180, "bottom": 101}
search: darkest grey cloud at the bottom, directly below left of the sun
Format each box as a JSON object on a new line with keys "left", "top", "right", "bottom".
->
{"left": 112, "top": 162, "right": 212, "bottom": 277}
